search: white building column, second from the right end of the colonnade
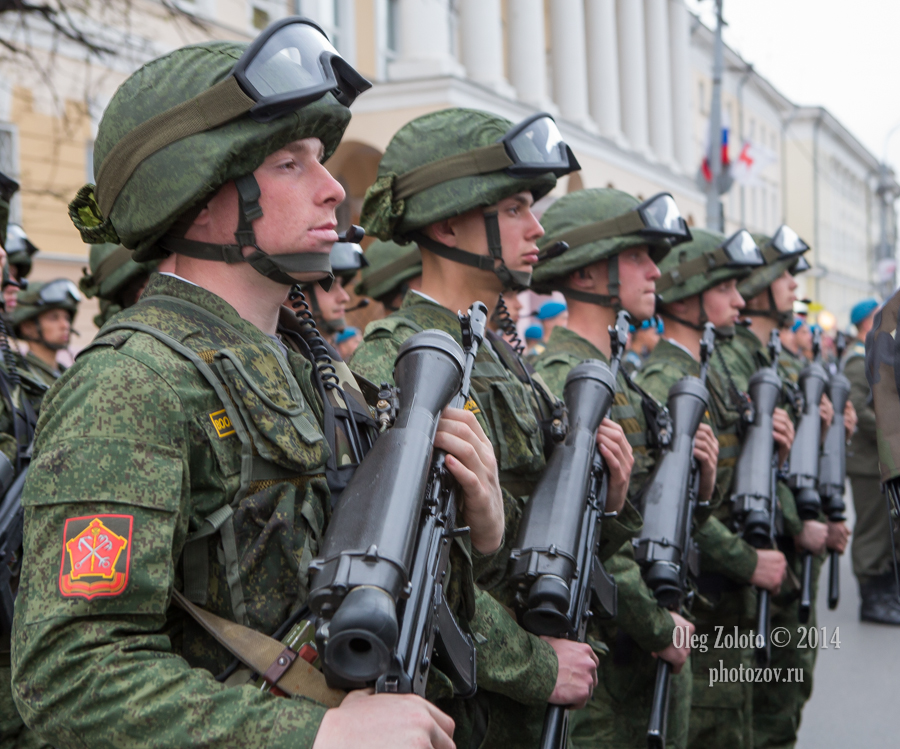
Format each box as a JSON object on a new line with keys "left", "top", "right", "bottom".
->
{"left": 644, "top": 0, "right": 678, "bottom": 169}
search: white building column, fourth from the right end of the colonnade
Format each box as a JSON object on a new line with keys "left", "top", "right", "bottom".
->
{"left": 585, "top": 0, "right": 625, "bottom": 146}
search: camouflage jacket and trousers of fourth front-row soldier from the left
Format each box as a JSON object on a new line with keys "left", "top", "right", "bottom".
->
{"left": 636, "top": 342, "right": 756, "bottom": 749}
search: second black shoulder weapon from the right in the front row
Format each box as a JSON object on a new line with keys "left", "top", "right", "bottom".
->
{"left": 788, "top": 328, "right": 838, "bottom": 624}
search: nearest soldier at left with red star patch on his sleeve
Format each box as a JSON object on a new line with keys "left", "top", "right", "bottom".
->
{"left": 12, "top": 24, "right": 503, "bottom": 749}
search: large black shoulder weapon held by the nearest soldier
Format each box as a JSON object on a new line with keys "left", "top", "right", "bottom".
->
{"left": 309, "top": 302, "right": 487, "bottom": 696}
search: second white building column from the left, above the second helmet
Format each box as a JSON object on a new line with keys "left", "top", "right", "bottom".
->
{"left": 459, "top": 0, "right": 515, "bottom": 98}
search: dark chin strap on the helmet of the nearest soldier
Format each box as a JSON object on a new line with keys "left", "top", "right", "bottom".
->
{"left": 159, "top": 174, "right": 334, "bottom": 290}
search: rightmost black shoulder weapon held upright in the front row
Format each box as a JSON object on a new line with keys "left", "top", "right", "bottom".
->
{"left": 819, "top": 333, "right": 850, "bottom": 609}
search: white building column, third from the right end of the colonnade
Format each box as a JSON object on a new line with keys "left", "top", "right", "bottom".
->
{"left": 616, "top": 0, "right": 652, "bottom": 158}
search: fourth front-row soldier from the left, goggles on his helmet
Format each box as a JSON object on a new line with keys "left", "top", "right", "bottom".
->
{"left": 635, "top": 229, "right": 786, "bottom": 749}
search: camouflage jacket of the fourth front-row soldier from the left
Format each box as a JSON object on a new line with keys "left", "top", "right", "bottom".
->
{"left": 636, "top": 339, "right": 757, "bottom": 590}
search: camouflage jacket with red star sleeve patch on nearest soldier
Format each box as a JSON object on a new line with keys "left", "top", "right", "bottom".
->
{"left": 12, "top": 276, "right": 354, "bottom": 748}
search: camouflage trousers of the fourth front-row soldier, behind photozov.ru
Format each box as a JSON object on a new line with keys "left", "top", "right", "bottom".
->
{"left": 688, "top": 624, "right": 753, "bottom": 749}
